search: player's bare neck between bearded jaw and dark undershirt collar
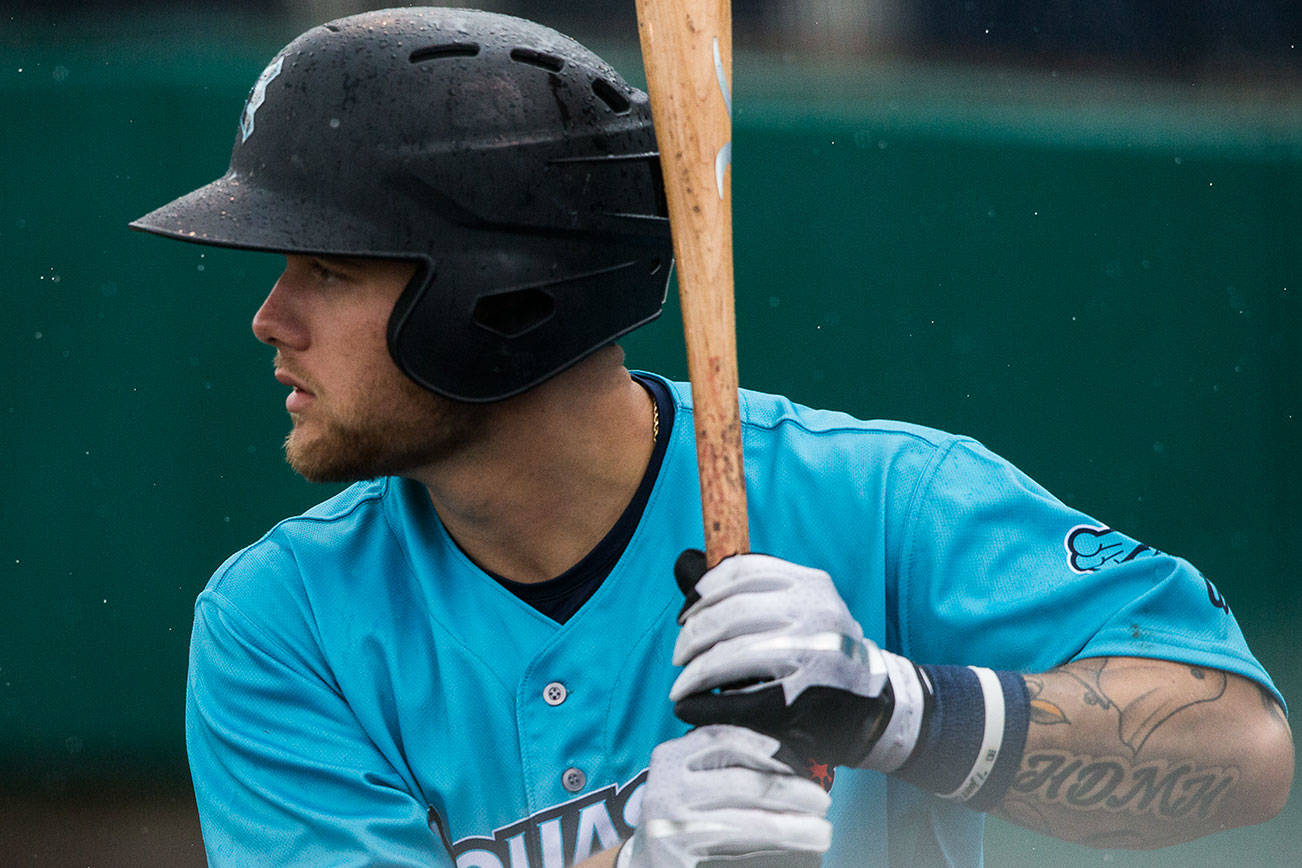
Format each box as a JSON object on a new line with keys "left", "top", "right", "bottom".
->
{"left": 410, "top": 347, "right": 655, "bottom": 582}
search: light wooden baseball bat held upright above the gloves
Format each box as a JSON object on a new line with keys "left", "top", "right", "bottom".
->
{"left": 637, "top": 0, "right": 750, "bottom": 566}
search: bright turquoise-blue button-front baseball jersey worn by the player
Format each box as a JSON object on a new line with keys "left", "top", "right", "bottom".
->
{"left": 186, "top": 384, "right": 1275, "bottom": 868}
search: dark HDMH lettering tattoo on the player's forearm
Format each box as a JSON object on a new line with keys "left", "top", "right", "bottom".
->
{"left": 1012, "top": 751, "right": 1240, "bottom": 820}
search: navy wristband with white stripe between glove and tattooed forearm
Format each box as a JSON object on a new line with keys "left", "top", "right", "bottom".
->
{"left": 888, "top": 666, "right": 1030, "bottom": 811}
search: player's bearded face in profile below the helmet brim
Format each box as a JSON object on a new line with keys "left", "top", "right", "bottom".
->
{"left": 253, "top": 255, "right": 484, "bottom": 481}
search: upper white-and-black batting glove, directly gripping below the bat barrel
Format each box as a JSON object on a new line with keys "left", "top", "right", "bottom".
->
{"left": 669, "top": 550, "right": 923, "bottom": 772}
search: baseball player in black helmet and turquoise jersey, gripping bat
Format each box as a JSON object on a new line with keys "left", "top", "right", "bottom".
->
{"left": 133, "top": 8, "right": 1293, "bottom": 868}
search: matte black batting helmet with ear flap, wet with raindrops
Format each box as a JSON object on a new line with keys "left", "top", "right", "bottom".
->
{"left": 132, "top": 8, "right": 673, "bottom": 401}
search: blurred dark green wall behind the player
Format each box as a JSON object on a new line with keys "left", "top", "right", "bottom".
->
{"left": 0, "top": 0, "right": 1302, "bottom": 865}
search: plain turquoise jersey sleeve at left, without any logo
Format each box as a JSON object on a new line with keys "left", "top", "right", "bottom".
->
{"left": 186, "top": 590, "right": 452, "bottom": 868}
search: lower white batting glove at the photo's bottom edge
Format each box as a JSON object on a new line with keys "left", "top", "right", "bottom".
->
{"left": 616, "top": 726, "right": 832, "bottom": 868}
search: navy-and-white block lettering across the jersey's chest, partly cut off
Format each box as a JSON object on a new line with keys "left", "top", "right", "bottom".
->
{"left": 430, "top": 770, "right": 647, "bottom": 868}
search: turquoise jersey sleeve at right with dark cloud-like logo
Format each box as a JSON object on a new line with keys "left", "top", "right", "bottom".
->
{"left": 896, "top": 439, "right": 1282, "bottom": 703}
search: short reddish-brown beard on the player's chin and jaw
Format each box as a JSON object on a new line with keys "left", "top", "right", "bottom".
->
{"left": 285, "top": 368, "right": 486, "bottom": 483}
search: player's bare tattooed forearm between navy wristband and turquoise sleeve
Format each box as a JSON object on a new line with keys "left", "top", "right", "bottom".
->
{"left": 993, "top": 657, "right": 1293, "bottom": 848}
